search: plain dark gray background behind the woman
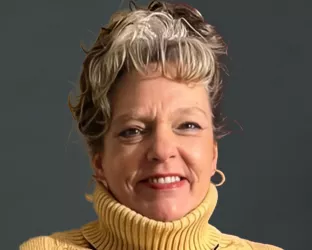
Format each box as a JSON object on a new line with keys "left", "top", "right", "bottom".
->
{"left": 0, "top": 0, "right": 312, "bottom": 249}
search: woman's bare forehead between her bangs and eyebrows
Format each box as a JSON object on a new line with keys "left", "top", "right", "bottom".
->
{"left": 111, "top": 71, "right": 209, "bottom": 110}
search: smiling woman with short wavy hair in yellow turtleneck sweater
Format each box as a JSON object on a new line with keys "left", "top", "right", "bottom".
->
{"left": 20, "top": 1, "right": 280, "bottom": 250}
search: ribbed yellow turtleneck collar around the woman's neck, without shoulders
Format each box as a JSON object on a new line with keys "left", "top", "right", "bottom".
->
{"left": 83, "top": 183, "right": 221, "bottom": 250}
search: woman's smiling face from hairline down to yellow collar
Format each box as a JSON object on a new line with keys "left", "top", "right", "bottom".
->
{"left": 93, "top": 68, "right": 218, "bottom": 221}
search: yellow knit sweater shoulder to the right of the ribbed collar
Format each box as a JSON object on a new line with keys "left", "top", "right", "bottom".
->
{"left": 220, "top": 233, "right": 283, "bottom": 250}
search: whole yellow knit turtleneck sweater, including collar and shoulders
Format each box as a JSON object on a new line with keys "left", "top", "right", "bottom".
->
{"left": 20, "top": 184, "right": 282, "bottom": 250}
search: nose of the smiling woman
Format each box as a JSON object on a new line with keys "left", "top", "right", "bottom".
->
{"left": 147, "top": 128, "right": 178, "bottom": 163}
